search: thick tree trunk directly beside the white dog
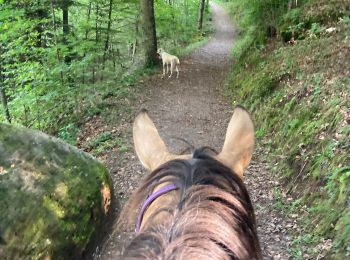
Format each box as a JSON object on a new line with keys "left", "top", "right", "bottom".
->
{"left": 140, "top": 0, "right": 158, "bottom": 66}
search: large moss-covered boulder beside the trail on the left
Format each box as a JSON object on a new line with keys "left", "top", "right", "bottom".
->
{"left": 0, "top": 124, "right": 111, "bottom": 259}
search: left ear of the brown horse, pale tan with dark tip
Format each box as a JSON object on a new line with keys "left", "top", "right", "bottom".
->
{"left": 133, "top": 109, "right": 169, "bottom": 171}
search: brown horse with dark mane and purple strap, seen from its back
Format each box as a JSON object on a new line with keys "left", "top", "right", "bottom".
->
{"left": 119, "top": 107, "right": 261, "bottom": 260}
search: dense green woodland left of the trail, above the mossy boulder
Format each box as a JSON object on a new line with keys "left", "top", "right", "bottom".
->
{"left": 0, "top": 0, "right": 208, "bottom": 133}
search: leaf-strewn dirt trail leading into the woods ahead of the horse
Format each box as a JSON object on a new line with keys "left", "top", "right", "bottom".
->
{"left": 93, "top": 3, "right": 293, "bottom": 259}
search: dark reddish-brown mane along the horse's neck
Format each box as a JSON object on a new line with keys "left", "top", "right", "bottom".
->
{"left": 119, "top": 147, "right": 261, "bottom": 260}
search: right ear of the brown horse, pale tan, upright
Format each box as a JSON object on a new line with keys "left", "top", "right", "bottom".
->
{"left": 216, "top": 106, "right": 255, "bottom": 178}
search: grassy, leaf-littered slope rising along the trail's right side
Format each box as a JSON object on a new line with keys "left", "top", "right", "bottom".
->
{"left": 229, "top": 1, "right": 350, "bottom": 259}
